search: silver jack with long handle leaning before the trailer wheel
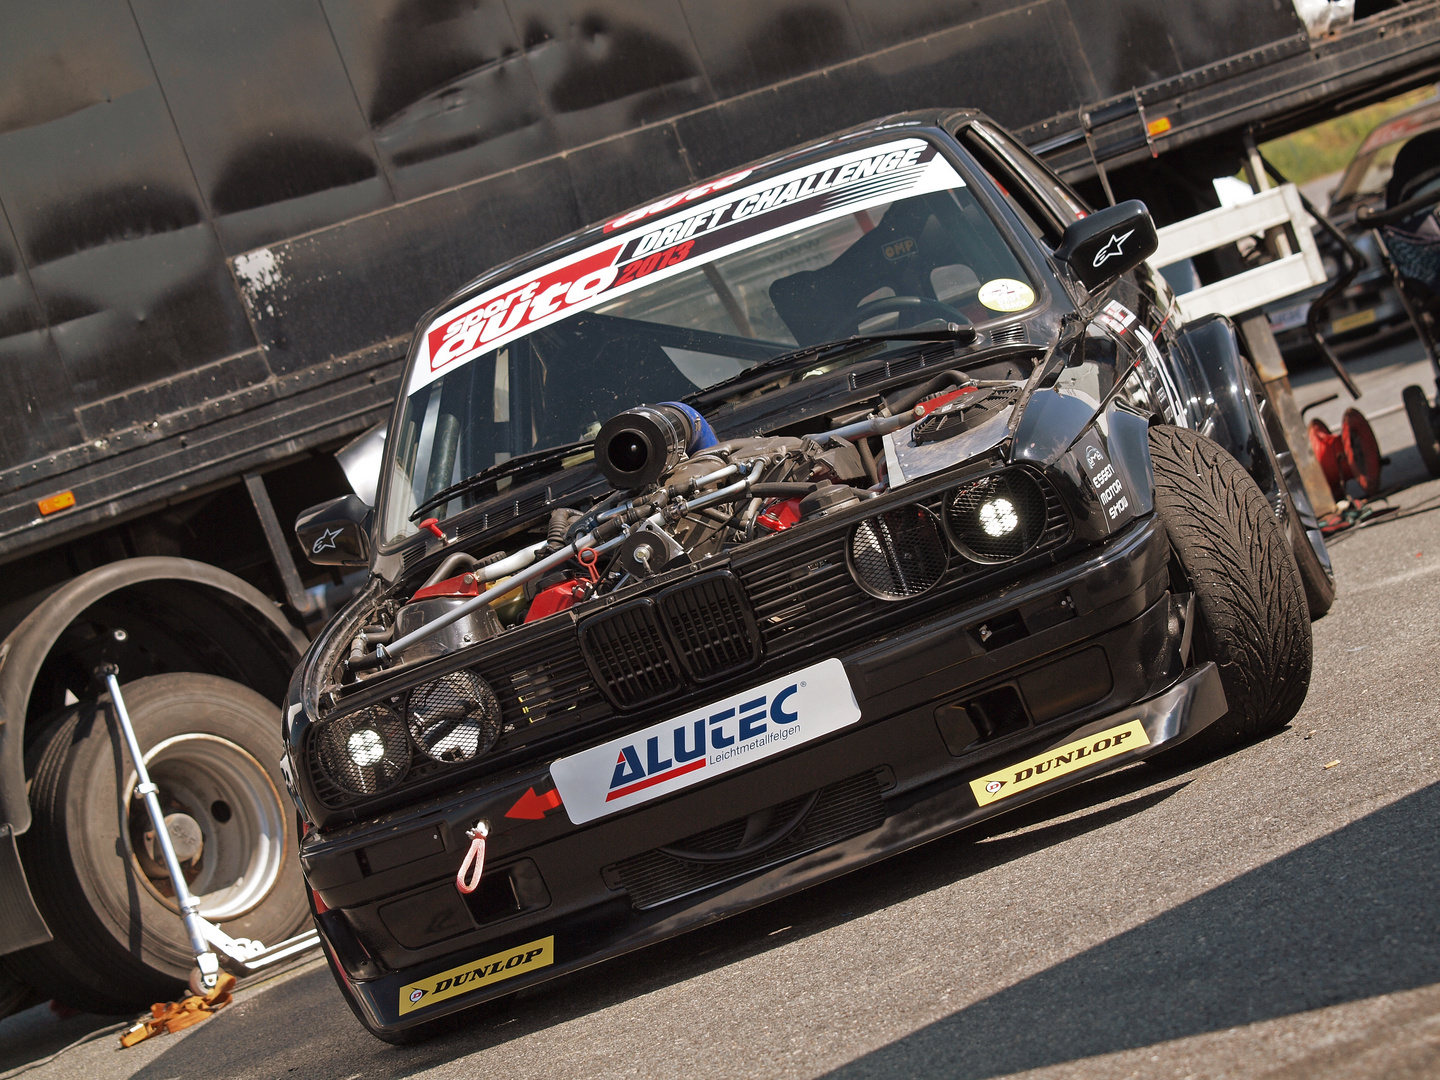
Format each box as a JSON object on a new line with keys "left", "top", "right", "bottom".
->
{"left": 96, "top": 665, "right": 320, "bottom": 996}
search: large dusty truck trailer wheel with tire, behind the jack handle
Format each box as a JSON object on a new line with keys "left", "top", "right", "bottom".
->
{"left": 6, "top": 672, "right": 310, "bottom": 1012}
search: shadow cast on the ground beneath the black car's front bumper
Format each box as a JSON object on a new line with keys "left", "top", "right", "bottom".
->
{"left": 109, "top": 765, "right": 1185, "bottom": 1080}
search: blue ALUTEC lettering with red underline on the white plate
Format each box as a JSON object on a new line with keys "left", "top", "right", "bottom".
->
{"left": 605, "top": 683, "right": 801, "bottom": 802}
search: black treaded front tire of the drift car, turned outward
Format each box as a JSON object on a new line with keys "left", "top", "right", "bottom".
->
{"left": 1151, "top": 426, "right": 1310, "bottom": 757}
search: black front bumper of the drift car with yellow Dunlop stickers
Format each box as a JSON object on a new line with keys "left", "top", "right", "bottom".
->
{"left": 302, "top": 518, "right": 1225, "bottom": 1031}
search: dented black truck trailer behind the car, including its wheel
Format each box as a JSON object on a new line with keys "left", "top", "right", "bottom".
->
{"left": 0, "top": 0, "right": 1440, "bottom": 1011}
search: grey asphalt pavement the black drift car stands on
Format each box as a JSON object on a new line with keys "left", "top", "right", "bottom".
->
{"left": 0, "top": 343, "right": 1440, "bottom": 1080}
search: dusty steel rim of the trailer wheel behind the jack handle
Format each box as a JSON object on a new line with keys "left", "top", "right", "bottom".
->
{"left": 122, "top": 733, "right": 288, "bottom": 922}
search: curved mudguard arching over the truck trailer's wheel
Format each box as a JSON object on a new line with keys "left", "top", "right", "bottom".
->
{"left": 0, "top": 557, "right": 310, "bottom": 835}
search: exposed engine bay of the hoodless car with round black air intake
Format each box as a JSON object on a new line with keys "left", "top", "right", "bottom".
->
{"left": 336, "top": 369, "right": 1024, "bottom": 683}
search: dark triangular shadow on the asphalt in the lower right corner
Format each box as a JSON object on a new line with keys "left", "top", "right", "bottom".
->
{"left": 829, "top": 785, "right": 1440, "bottom": 1080}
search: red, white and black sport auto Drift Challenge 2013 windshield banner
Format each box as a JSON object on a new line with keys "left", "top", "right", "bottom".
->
{"left": 406, "top": 138, "right": 965, "bottom": 393}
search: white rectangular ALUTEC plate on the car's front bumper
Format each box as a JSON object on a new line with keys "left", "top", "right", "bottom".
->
{"left": 550, "top": 660, "right": 860, "bottom": 825}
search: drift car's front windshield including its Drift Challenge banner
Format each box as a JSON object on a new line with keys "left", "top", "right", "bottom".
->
{"left": 380, "top": 138, "right": 1037, "bottom": 543}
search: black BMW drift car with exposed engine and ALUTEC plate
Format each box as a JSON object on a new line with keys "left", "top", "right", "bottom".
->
{"left": 285, "top": 111, "right": 1333, "bottom": 1041}
